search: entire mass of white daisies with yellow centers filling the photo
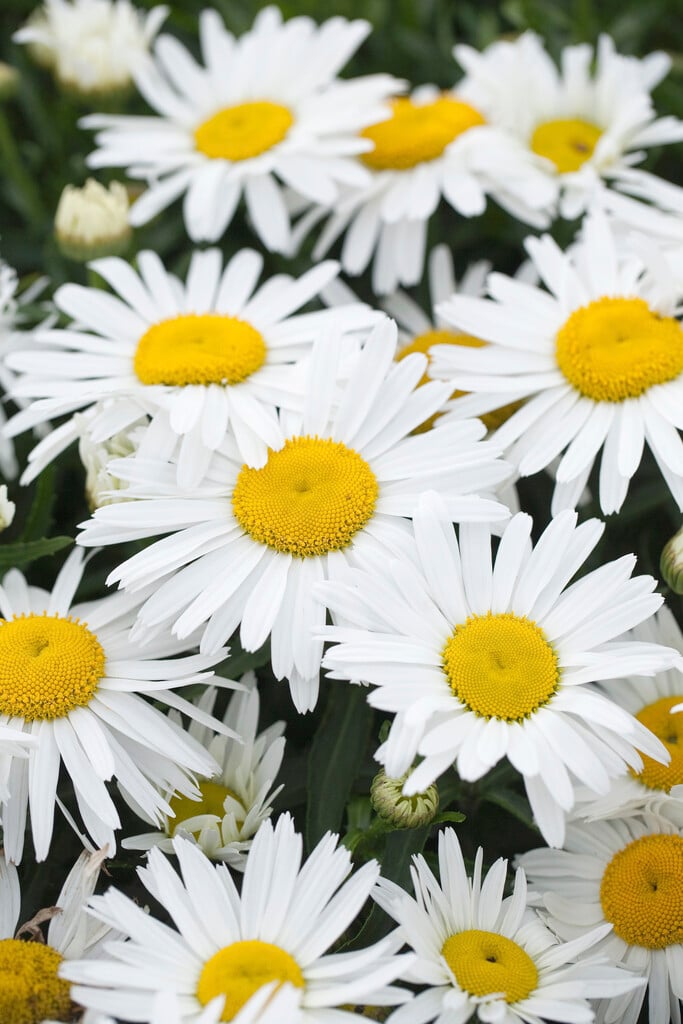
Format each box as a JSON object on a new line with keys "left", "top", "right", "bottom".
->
{"left": 0, "top": 0, "right": 683, "bottom": 1024}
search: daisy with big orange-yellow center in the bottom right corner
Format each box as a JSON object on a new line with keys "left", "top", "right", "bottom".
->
{"left": 518, "top": 814, "right": 683, "bottom": 1024}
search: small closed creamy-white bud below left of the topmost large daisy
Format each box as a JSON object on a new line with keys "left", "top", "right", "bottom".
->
{"left": 54, "top": 178, "right": 132, "bottom": 261}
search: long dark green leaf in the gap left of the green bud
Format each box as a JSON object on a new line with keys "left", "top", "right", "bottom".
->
{"left": 306, "top": 683, "right": 373, "bottom": 850}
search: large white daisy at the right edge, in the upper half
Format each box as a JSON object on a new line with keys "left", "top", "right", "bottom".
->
{"left": 431, "top": 212, "right": 683, "bottom": 513}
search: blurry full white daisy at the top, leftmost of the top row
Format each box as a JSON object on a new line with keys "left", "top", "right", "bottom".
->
{"left": 81, "top": 7, "right": 400, "bottom": 252}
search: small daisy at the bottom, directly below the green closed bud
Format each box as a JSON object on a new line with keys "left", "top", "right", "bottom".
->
{"left": 373, "top": 828, "right": 643, "bottom": 1024}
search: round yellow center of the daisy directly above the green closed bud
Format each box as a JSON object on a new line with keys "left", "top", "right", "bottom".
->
{"left": 442, "top": 611, "right": 560, "bottom": 722}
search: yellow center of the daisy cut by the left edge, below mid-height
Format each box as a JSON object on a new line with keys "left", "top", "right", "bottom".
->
{"left": 0, "top": 614, "right": 104, "bottom": 722}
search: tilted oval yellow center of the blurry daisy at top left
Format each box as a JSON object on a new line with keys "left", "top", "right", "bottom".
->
{"left": 195, "top": 99, "right": 294, "bottom": 161}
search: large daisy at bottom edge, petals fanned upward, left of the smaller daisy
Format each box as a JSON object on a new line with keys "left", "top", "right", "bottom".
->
{"left": 65, "top": 815, "right": 412, "bottom": 1024}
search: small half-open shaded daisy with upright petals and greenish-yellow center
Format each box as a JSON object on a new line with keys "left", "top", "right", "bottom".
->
{"left": 121, "top": 672, "right": 285, "bottom": 871}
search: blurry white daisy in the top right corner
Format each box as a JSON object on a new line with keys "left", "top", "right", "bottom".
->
{"left": 454, "top": 32, "right": 683, "bottom": 219}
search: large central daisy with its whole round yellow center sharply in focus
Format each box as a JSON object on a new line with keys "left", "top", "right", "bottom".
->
{"left": 79, "top": 318, "right": 509, "bottom": 712}
